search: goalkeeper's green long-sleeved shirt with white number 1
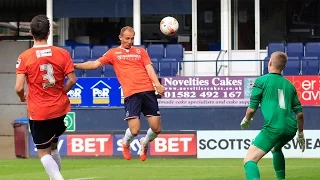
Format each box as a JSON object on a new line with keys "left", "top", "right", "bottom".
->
{"left": 249, "top": 73, "right": 302, "bottom": 134}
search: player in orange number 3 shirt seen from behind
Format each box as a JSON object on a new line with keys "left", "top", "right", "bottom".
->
{"left": 15, "top": 15, "right": 76, "bottom": 180}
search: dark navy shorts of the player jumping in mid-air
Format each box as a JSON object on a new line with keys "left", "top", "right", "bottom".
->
{"left": 124, "top": 91, "right": 160, "bottom": 120}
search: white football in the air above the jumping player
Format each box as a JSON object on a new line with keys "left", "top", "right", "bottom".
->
{"left": 160, "top": 16, "right": 179, "bottom": 36}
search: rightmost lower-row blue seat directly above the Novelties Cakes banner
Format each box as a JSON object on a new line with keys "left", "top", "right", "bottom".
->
{"left": 160, "top": 58, "right": 178, "bottom": 76}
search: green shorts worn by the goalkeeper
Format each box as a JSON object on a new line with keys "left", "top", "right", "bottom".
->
{"left": 252, "top": 128, "right": 295, "bottom": 153}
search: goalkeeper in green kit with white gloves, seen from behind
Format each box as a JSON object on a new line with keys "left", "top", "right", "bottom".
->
{"left": 240, "top": 52, "right": 305, "bottom": 180}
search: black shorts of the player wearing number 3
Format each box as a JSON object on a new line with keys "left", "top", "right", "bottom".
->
{"left": 29, "top": 115, "right": 67, "bottom": 149}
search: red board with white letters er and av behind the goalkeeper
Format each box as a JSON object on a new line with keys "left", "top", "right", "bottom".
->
{"left": 286, "top": 76, "right": 320, "bottom": 106}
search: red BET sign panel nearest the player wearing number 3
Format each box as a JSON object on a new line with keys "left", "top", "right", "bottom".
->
{"left": 67, "top": 134, "right": 113, "bottom": 156}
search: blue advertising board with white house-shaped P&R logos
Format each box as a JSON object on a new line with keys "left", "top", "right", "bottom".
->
{"left": 68, "top": 78, "right": 124, "bottom": 107}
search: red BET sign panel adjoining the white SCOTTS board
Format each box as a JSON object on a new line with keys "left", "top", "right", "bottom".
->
{"left": 150, "top": 134, "right": 197, "bottom": 156}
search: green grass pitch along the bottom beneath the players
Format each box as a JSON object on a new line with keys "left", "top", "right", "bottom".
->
{"left": 0, "top": 158, "right": 320, "bottom": 180}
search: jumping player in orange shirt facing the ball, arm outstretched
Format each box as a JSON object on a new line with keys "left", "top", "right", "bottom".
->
{"left": 75, "top": 26, "right": 164, "bottom": 161}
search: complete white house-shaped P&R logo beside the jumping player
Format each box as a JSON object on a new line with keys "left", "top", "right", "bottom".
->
{"left": 90, "top": 80, "right": 111, "bottom": 104}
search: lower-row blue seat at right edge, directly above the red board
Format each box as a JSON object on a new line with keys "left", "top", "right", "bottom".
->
{"left": 302, "top": 57, "right": 319, "bottom": 75}
